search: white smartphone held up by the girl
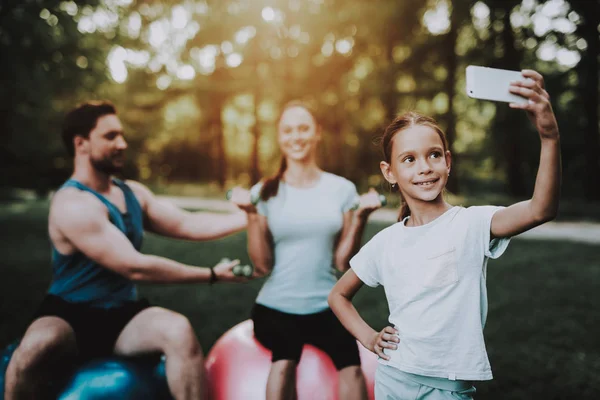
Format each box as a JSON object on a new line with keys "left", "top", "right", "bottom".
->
{"left": 467, "top": 65, "right": 527, "bottom": 104}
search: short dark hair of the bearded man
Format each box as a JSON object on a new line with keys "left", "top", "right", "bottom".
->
{"left": 62, "top": 101, "right": 117, "bottom": 156}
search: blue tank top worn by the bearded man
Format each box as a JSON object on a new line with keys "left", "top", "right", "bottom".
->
{"left": 48, "top": 179, "right": 144, "bottom": 308}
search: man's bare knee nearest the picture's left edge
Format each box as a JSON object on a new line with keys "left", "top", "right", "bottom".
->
{"left": 13, "top": 317, "right": 77, "bottom": 368}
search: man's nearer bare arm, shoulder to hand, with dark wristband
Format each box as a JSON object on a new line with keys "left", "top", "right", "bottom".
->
{"left": 51, "top": 193, "right": 240, "bottom": 283}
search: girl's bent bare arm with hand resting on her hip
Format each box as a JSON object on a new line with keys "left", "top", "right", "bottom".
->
{"left": 327, "top": 269, "right": 399, "bottom": 360}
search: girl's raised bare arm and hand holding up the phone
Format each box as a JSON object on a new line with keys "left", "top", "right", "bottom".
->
{"left": 491, "top": 70, "right": 561, "bottom": 237}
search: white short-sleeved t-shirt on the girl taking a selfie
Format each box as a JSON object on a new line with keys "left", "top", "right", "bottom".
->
{"left": 350, "top": 206, "right": 510, "bottom": 380}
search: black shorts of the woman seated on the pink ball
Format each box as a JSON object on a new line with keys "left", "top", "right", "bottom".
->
{"left": 252, "top": 304, "right": 360, "bottom": 370}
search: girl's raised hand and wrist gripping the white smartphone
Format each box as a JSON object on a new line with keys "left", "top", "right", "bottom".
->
{"left": 509, "top": 69, "right": 558, "bottom": 139}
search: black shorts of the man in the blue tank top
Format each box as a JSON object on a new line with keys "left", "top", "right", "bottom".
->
{"left": 35, "top": 294, "right": 150, "bottom": 361}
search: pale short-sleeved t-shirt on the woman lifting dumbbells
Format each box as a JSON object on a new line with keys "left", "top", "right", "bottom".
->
{"left": 251, "top": 172, "right": 358, "bottom": 315}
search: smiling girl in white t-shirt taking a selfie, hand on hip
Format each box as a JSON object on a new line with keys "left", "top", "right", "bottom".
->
{"left": 329, "top": 70, "right": 560, "bottom": 400}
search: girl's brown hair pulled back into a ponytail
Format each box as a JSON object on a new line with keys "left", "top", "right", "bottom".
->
{"left": 381, "top": 111, "right": 448, "bottom": 221}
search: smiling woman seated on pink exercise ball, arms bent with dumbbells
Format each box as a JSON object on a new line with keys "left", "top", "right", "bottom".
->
{"left": 231, "top": 102, "right": 381, "bottom": 399}
